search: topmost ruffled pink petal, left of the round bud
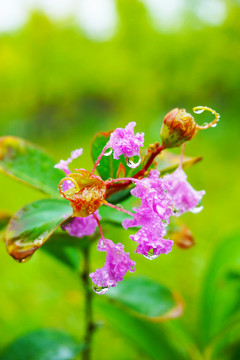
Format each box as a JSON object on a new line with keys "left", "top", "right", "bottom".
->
{"left": 108, "top": 122, "right": 144, "bottom": 160}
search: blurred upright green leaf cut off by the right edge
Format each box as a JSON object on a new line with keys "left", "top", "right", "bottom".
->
{"left": 199, "top": 234, "right": 240, "bottom": 345}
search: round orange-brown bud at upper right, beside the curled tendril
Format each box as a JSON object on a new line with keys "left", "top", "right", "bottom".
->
{"left": 160, "top": 108, "right": 198, "bottom": 148}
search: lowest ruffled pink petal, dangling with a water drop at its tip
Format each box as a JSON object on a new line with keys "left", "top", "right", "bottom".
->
{"left": 89, "top": 238, "right": 135, "bottom": 294}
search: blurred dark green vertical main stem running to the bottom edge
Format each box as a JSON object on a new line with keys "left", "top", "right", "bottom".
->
{"left": 82, "top": 247, "right": 95, "bottom": 360}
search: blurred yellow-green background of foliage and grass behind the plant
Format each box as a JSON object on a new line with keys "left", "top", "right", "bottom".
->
{"left": 0, "top": 0, "right": 240, "bottom": 359}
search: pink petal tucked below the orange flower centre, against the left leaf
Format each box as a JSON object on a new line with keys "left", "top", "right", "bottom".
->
{"left": 62, "top": 210, "right": 101, "bottom": 238}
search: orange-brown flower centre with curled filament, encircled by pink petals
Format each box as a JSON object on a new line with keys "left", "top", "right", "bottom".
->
{"left": 59, "top": 170, "right": 106, "bottom": 217}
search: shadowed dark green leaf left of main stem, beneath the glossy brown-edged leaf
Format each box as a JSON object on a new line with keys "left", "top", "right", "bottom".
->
{"left": 41, "top": 233, "right": 85, "bottom": 271}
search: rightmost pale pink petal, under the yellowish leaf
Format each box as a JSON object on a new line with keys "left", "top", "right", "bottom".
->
{"left": 163, "top": 168, "right": 205, "bottom": 216}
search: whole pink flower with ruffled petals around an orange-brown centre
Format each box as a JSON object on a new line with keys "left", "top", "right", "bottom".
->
{"left": 56, "top": 113, "right": 213, "bottom": 294}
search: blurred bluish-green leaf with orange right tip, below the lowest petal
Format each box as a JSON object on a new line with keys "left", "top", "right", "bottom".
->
{"left": 106, "top": 277, "right": 183, "bottom": 321}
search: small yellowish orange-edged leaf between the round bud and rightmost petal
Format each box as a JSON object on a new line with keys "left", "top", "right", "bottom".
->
{"left": 155, "top": 150, "right": 202, "bottom": 176}
